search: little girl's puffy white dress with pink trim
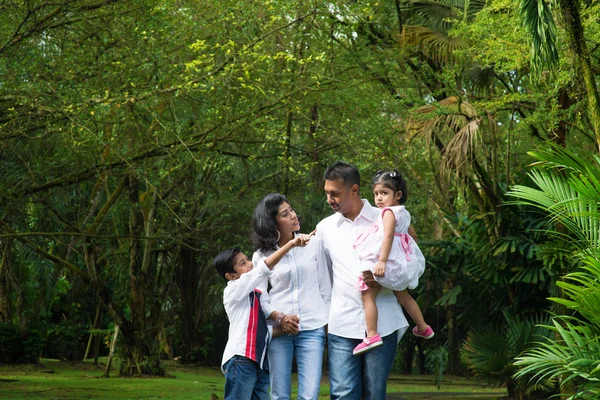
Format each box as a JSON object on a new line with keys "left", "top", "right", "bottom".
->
{"left": 353, "top": 206, "right": 425, "bottom": 290}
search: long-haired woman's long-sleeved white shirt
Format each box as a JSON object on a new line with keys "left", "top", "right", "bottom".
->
{"left": 252, "top": 237, "right": 331, "bottom": 330}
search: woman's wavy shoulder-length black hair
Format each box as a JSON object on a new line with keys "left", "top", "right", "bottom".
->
{"left": 252, "top": 193, "right": 289, "bottom": 253}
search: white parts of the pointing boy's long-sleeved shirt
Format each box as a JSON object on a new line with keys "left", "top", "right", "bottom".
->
{"left": 221, "top": 258, "right": 273, "bottom": 372}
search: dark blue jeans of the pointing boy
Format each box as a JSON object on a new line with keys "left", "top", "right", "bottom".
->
{"left": 223, "top": 356, "right": 269, "bottom": 400}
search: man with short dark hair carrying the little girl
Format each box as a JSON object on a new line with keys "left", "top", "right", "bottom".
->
{"left": 317, "top": 161, "right": 408, "bottom": 400}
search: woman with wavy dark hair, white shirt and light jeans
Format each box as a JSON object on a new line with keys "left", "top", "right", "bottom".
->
{"left": 252, "top": 193, "right": 331, "bottom": 400}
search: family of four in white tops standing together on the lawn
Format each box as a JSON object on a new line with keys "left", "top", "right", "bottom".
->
{"left": 214, "top": 161, "right": 434, "bottom": 400}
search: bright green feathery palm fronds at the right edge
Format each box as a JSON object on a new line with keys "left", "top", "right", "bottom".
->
{"left": 511, "top": 147, "right": 600, "bottom": 399}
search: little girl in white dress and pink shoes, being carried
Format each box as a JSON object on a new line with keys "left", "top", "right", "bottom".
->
{"left": 353, "top": 170, "right": 434, "bottom": 355}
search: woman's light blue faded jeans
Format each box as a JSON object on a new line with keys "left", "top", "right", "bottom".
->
{"left": 268, "top": 328, "right": 325, "bottom": 400}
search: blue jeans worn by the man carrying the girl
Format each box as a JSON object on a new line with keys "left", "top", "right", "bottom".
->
{"left": 327, "top": 331, "right": 398, "bottom": 400}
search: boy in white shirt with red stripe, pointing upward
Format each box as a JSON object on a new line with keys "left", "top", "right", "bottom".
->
{"left": 213, "top": 235, "right": 310, "bottom": 400}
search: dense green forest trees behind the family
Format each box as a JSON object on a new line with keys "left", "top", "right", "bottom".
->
{"left": 0, "top": 0, "right": 600, "bottom": 396}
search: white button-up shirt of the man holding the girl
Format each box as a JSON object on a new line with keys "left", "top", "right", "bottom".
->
{"left": 317, "top": 199, "right": 408, "bottom": 341}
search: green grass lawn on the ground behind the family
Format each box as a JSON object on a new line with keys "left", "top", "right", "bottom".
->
{"left": 0, "top": 359, "right": 506, "bottom": 400}
